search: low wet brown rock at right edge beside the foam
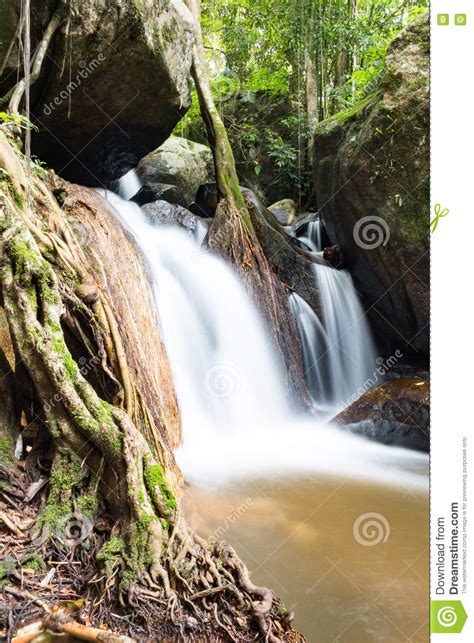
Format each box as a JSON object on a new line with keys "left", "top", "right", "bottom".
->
{"left": 334, "top": 378, "right": 430, "bottom": 452}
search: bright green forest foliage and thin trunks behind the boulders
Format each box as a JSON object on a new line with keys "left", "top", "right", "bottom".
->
{"left": 175, "top": 0, "right": 428, "bottom": 203}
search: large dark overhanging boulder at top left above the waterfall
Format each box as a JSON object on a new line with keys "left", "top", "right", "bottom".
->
{"left": 0, "top": 0, "right": 194, "bottom": 186}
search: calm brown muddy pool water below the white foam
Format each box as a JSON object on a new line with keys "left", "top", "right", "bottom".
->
{"left": 185, "top": 477, "right": 429, "bottom": 643}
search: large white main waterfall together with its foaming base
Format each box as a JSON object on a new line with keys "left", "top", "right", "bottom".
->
{"left": 101, "top": 191, "right": 427, "bottom": 488}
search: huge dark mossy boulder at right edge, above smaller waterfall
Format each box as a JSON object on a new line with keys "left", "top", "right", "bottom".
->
{"left": 314, "top": 15, "right": 430, "bottom": 360}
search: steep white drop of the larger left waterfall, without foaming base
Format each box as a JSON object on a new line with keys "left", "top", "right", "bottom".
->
{"left": 98, "top": 192, "right": 290, "bottom": 437}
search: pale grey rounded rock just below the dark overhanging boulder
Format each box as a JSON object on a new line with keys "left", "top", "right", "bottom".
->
{"left": 138, "top": 136, "right": 214, "bottom": 207}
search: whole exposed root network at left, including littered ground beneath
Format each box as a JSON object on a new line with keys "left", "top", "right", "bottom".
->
{"left": 0, "top": 105, "right": 301, "bottom": 641}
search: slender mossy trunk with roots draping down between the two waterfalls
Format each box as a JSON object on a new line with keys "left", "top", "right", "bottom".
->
{"left": 187, "top": 0, "right": 311, "bottom": 407}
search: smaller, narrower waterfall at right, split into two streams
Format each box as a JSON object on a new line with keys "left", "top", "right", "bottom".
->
{"left": 290, "top": 220, "right": 376, "bottom": 417}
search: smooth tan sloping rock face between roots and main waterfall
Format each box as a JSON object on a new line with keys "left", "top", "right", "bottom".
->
{"left": 62, "top": 181, "right": 181, "bottom": 460}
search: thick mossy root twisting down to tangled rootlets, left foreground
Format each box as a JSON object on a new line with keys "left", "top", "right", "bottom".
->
{"left": 0, "top": 172, "right": 304, "bottom": 642}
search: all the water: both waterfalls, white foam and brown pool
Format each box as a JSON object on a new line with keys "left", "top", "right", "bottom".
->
{"left": 101, "top": 191, "right": 428, "bottom": 643}
